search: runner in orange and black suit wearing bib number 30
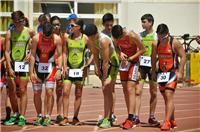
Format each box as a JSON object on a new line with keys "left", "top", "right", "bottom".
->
{"left": 152, "top": 24, "right": 186, "bottom": 131}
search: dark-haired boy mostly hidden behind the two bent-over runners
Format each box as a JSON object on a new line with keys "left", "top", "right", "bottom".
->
{"left": 102, "top": 13, "right": 117, "bottom": 124}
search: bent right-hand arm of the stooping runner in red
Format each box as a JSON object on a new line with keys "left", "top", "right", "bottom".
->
{"left": 129, "top": 32, "right": 146, "bottom": 60}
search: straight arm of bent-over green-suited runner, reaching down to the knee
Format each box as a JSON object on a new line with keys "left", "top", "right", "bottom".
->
{"left": 100, "top": 38, "right": 111, "bottom": 80}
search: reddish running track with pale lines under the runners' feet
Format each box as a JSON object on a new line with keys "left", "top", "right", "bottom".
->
{"left": 1, "top": 85, "right": 200, "bottom": 132}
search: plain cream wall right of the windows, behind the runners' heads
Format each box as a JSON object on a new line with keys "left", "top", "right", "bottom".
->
{"left": 120, "top": 1, "right": 200, "bottom": 35}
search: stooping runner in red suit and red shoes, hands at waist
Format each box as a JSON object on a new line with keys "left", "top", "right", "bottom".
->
{"left": 112, "top": 25, "right": 145, "bottom": 129}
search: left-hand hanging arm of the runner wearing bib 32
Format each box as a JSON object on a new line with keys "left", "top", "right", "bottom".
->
{"left": 29, "top": 34, "right": 39, "bottom": 76}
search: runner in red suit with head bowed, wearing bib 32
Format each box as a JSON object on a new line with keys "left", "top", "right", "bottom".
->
{"left": 30, "top": 22, "right": 62, "bottom": 126}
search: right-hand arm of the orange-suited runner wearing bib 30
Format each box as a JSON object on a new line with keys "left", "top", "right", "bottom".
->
{"left": 172, "top": 38, "right": 186, "bottom": 81}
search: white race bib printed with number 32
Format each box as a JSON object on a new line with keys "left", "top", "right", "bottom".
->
{"left": 38, "top": 63, "right": 52, "bottom": 73}
